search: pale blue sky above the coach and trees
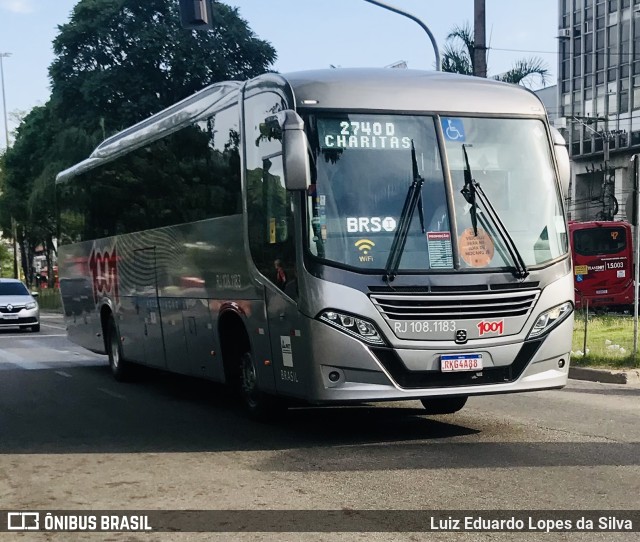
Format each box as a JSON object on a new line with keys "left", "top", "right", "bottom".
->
{"left": 0, "top": 0, "right": 558, "bottom": 152}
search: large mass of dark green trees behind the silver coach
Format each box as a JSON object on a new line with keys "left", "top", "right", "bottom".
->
{"left": 0, "top": 0, "right": 276, "bottom": 280}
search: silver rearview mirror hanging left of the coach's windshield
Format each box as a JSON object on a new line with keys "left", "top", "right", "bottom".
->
{"left": 276, "top": 109, "right": 311, "bottom": 190}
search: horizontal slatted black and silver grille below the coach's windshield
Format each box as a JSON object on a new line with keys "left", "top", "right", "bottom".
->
{"left": 371, "top": 290, "right": 540, "bottom": 320}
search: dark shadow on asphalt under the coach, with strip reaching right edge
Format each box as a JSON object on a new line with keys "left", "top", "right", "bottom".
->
{"left": 0, "top": 366, "right": 640, "bottom": 472}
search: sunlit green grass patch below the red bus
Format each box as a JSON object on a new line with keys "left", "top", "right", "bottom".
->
{"left": 571, "top": 311, "right": 638, "bottom": 369}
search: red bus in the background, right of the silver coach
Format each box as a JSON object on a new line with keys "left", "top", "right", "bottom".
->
{"left": 569, "top": 221, "right": 633, "bottom": 310}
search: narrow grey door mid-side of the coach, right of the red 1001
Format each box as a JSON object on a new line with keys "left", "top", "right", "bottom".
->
{"left": 133, "top": 247, "right": 166, "bottom": 368}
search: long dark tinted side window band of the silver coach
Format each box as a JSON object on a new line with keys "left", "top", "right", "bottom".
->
{"left": 59, "top": 107, "right": 241, "bottom": 242}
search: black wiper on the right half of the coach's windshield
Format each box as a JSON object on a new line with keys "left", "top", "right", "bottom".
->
{"left": 460, "top": 143, "right": 529, "bottom": 279}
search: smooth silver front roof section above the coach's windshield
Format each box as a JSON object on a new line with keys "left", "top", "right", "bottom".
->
{"left": 283, "top": 68, "right": 546, "bottom": 116}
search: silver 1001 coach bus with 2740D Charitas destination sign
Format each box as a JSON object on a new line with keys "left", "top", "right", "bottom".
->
{"left": 57, "top": 69, "right": 573, "bottom": 415}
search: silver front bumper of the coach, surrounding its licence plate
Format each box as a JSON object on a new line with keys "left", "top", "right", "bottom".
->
{"left": 311, "top": 315, "right": 573, "bottom": 403}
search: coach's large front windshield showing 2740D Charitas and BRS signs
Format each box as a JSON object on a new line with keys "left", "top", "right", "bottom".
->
{"left": 308, "top": 113, "right": 568, "bottom": 273}
